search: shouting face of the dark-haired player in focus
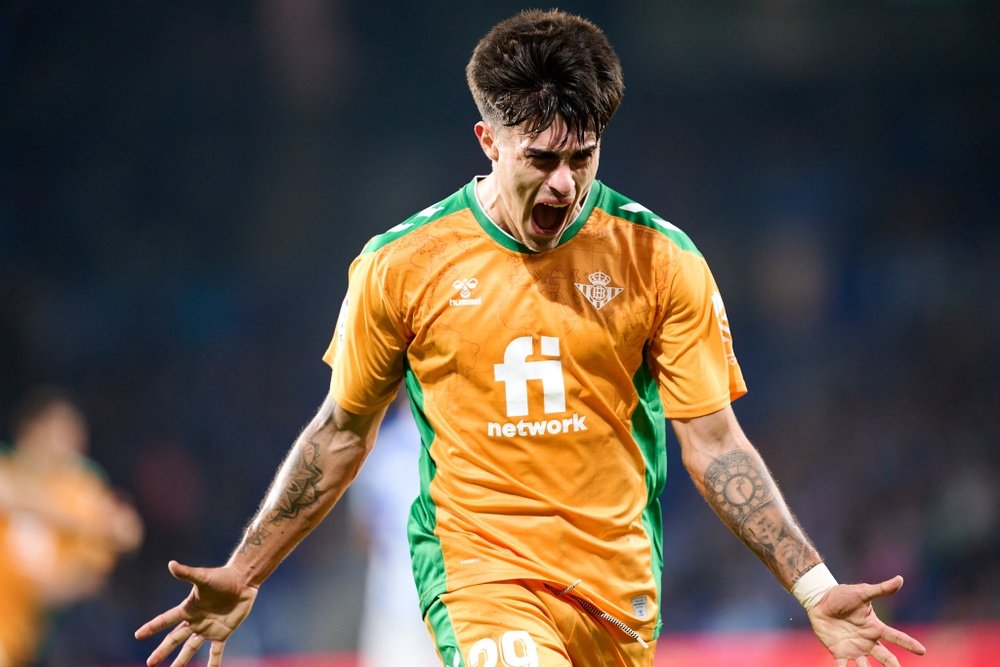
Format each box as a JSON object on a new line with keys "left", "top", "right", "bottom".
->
{"left": 476, "top": 120, "right": 600, "bottom": 252}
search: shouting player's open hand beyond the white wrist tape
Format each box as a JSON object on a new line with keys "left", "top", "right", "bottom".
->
{"left": 809, "top": 576, "right": 926, "bottom": 667}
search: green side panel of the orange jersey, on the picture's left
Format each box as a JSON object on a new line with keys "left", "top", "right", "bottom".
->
{"left": 404, "top": 363, "right": 446, "bottom": 613}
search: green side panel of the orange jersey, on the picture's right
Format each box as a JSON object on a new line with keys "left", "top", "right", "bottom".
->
{"left": 632, "top": 363, "right": 667, "bottom": 636}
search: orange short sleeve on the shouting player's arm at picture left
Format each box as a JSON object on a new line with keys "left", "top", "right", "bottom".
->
{"left": 323, "top": 253, "right": 409, "bottom": 414}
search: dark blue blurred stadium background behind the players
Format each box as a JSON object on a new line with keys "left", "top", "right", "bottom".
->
{"left": 0, "top": 0, "right": 1000, "bottom": 665}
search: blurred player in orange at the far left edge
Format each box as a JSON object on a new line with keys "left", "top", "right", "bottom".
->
{"left": 0, "top": 388, "right": 142, "bottom": 667}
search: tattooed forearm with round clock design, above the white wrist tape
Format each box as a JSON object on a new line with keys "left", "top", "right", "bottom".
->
{"left": 705, "top": 450, "right": 819, "bottom": 585}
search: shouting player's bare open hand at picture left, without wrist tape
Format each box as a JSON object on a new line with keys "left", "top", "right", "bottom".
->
{"left": 135, "top": 560, "right": 257, "bottom": 667}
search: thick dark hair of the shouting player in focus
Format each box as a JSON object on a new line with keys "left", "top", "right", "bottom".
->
{"left": 465, "top": 9, "right": 625, "bottom": 140}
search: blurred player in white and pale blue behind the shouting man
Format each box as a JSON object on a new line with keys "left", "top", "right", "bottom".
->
{"left": 347, "top": 389, "right": 441, "bottom": 667}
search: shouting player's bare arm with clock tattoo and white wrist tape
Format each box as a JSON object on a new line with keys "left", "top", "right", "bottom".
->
{"left": 673, "top": 407, "right": 925, "bottom": 667}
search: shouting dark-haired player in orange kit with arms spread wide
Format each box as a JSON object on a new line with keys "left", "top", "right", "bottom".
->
{"left": 136, "top": 11, "right": 924, "bottom": 667}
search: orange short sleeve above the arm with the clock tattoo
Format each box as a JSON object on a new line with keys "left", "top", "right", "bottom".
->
{"left": 648, "top": 249, "right": 747, "bottom": 418}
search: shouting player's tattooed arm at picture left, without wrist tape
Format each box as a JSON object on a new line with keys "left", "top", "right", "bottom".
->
{"left": 135, "top": 396, "right": 385, "bottom": 667}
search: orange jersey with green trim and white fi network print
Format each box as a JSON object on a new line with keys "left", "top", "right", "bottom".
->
{"left": 324, "top": 180, "right": 746, "bottom": 639}
